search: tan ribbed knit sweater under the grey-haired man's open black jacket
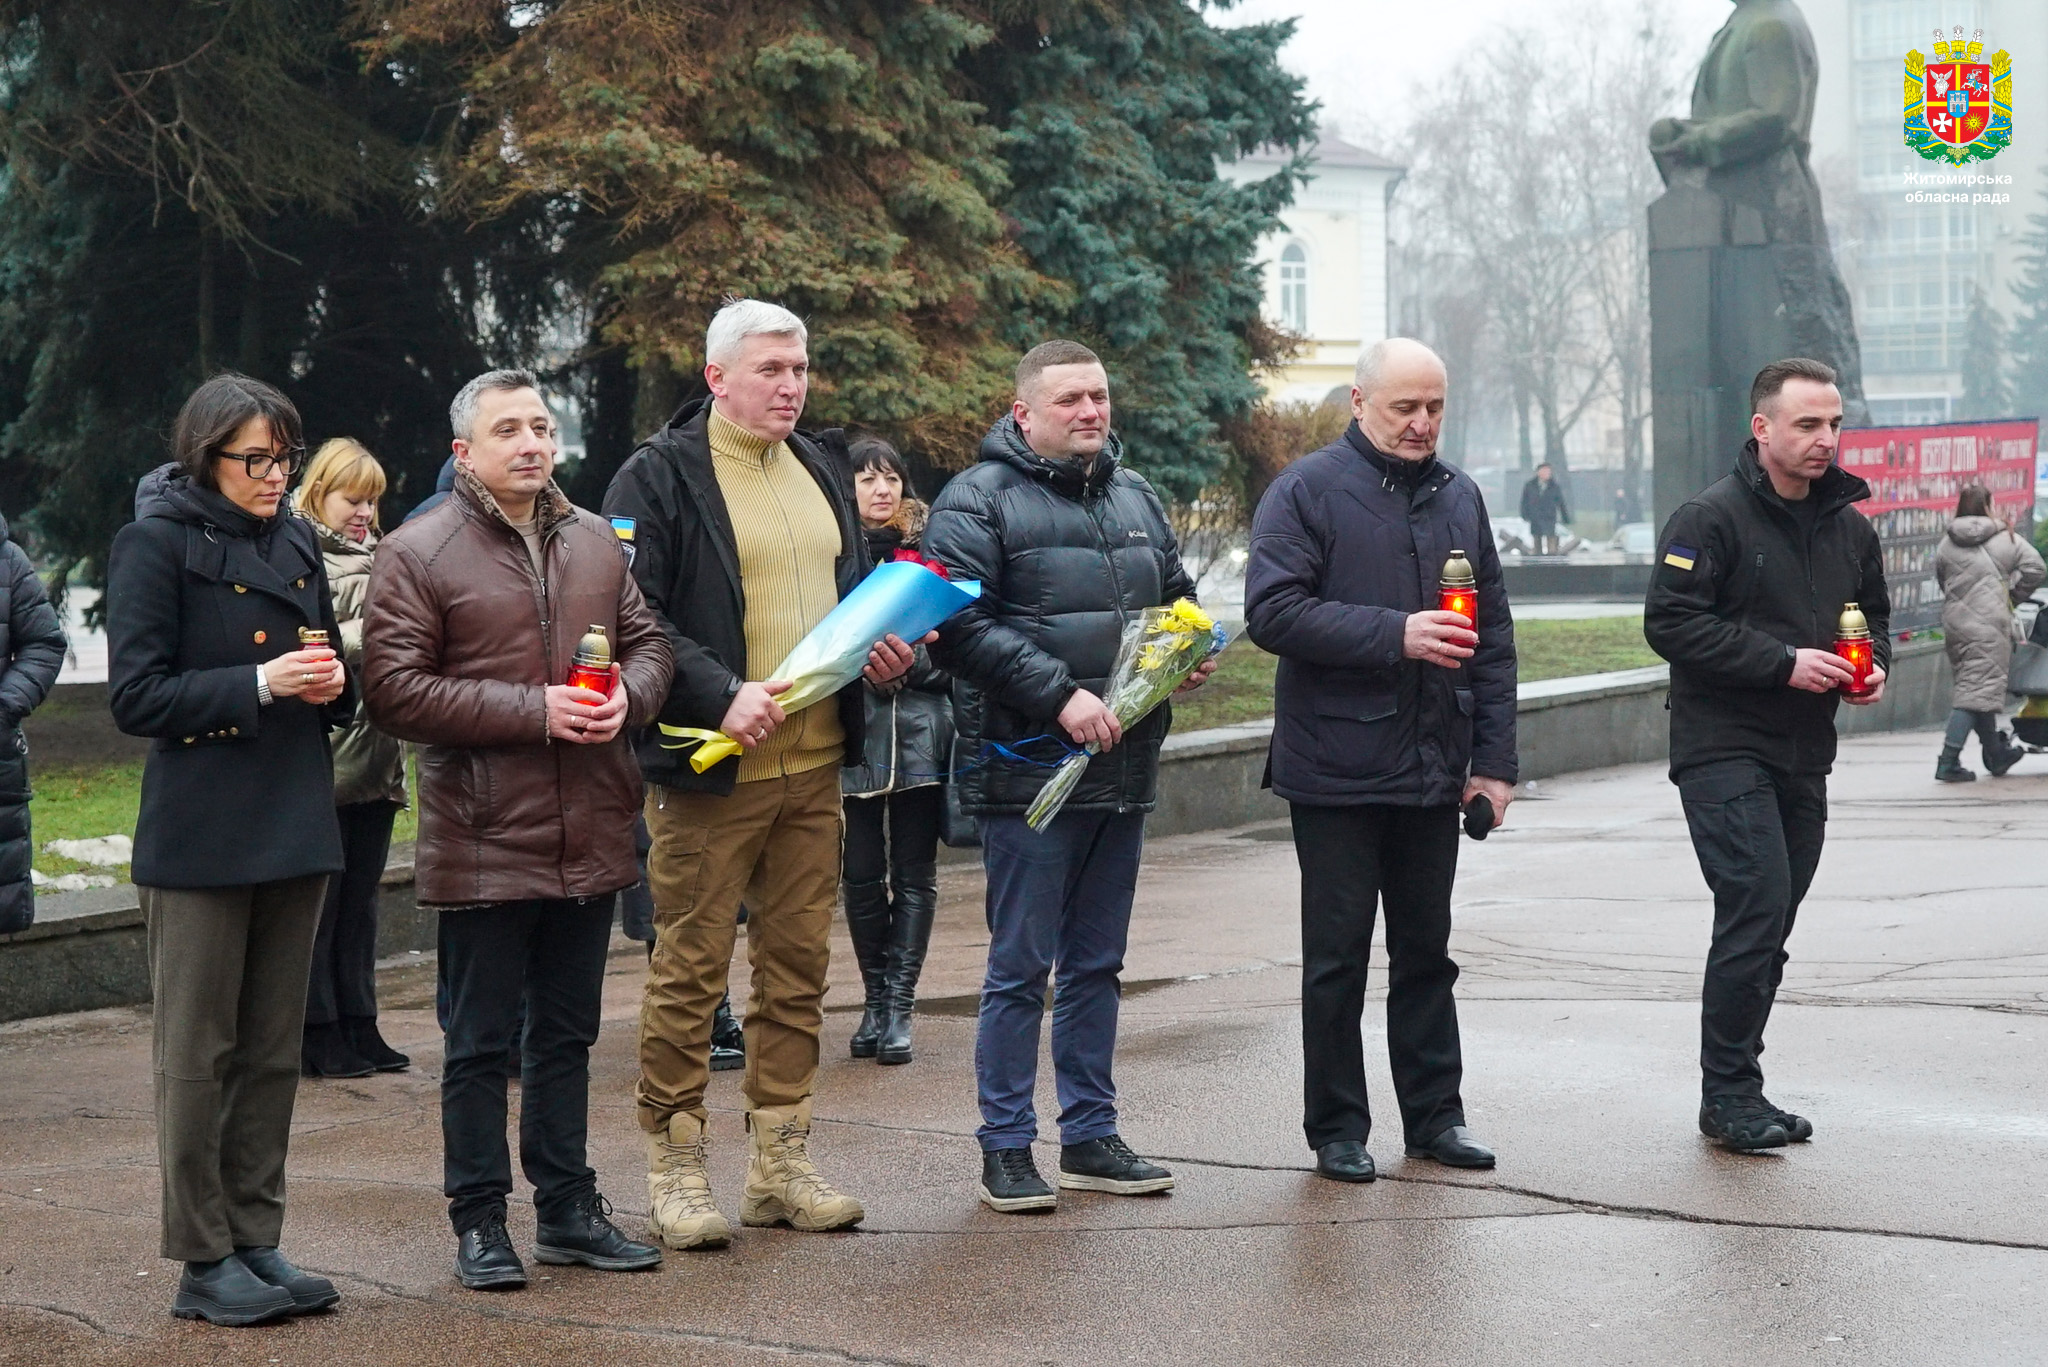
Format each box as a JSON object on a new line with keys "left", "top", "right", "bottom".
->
{"left": 705, "top": 406, "right": 846, "bottom": 783}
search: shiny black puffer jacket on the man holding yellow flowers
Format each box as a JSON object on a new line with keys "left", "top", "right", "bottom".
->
{"left": 924, "top": 418, "right": 1194, "bottom": 816}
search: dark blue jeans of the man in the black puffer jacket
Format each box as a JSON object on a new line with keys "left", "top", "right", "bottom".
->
{"left": 975, "top": 812, "right": 1145, "bottom": 1150}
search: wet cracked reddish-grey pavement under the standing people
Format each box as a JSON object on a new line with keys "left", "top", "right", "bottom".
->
{"left": 0, "top": 734, "right": 2048, "bottom": 1367}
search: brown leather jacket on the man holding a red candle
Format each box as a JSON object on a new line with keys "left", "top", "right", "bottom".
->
{"left": 362, "top": 475, "right": 674, "bottom": 906}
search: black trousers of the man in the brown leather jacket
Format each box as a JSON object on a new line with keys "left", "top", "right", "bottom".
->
{"left": 440, "top": 894, "right": 616, "bottom": 1234}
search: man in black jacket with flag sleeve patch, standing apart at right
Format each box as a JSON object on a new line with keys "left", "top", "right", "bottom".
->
{"left": 1642, "top": 359, "right": 1890, "bottom": 1150}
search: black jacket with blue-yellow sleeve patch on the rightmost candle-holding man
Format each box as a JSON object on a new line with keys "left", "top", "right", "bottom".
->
{"left": 1642, "top": 441, "right": 1892, "bottom": 779}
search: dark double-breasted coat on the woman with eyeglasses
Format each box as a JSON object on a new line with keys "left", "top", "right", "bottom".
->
{"left": 106, "top": 465, "right": 356, "bottom": 887}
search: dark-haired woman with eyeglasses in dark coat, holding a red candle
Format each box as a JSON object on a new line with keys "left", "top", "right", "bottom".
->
{"left": 106, "top": 375, "right": 354, "bottom": 1324}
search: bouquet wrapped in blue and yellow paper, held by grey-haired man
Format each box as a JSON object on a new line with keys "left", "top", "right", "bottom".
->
{"left": 659, "top": 560, "right": 981, "bottom": 773}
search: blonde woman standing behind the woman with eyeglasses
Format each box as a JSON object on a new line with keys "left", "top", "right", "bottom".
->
{"left": 295, "top": 437, "right": 412, "bottom": 1078}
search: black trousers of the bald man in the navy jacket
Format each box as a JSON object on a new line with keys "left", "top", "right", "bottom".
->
{"left": 1294, "top": 803, "right": 1464, "bottom": 1148}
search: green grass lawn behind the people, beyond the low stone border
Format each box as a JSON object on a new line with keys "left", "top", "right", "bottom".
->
{"left": 29, "top": 617, "right": 1657, "bottom": 881}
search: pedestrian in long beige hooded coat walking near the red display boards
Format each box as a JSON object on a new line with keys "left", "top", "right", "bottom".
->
{"left": 1933, "top": 484, "right": 2048, "bottom": 783}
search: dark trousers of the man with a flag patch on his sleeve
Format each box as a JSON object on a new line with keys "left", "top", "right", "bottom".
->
{"left": 1677, "top": 760, "right": 1827, "bottom": 1096}
